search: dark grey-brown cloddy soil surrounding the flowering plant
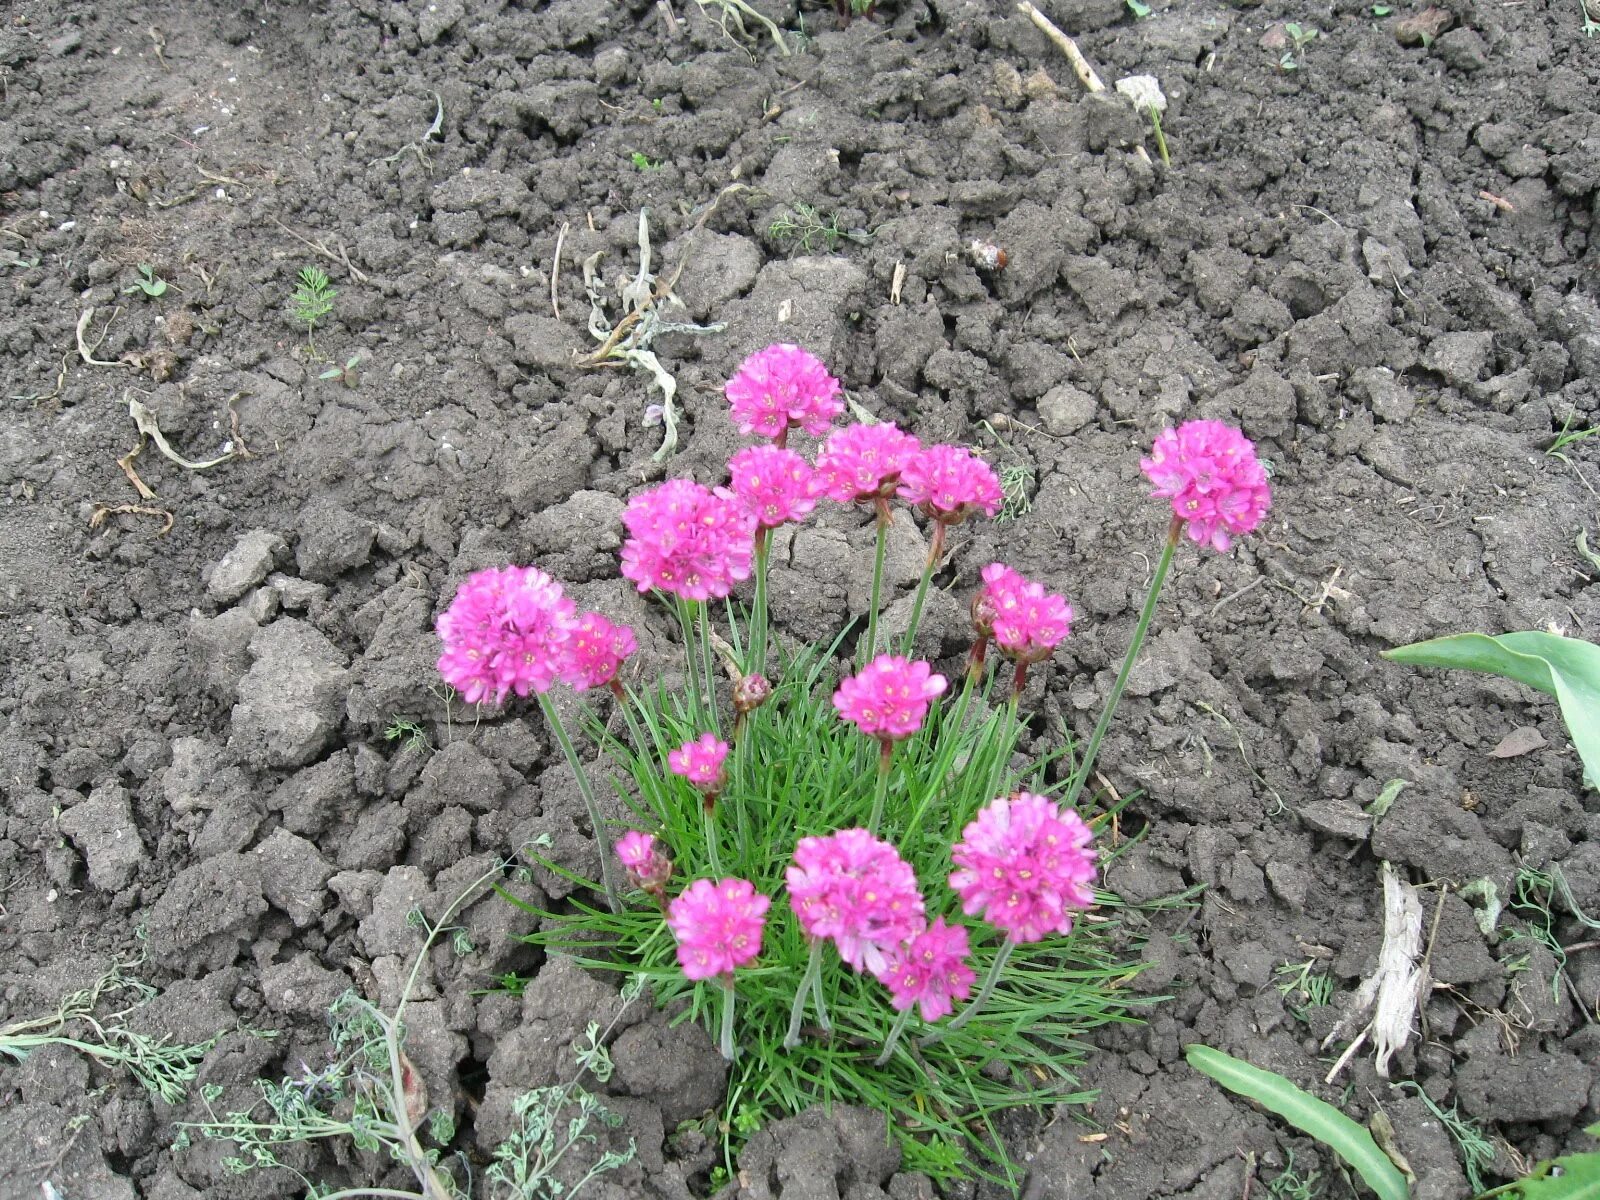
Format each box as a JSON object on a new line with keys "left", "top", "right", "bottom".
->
{"left": 0, "top": 0, "right": 1600, "bottom": 1200}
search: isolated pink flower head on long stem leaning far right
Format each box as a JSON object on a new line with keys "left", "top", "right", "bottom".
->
{"left": 1139, "top": 421, "right": 1272, "bottom": 554}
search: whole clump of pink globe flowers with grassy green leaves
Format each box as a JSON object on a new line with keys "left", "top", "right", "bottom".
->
{"left": 438, "top": 346, "right": 1269, "bottom": 1184}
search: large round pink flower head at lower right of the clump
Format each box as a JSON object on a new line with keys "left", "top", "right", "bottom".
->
{"left": 950, "top": 792, "right": 1094, "bottom": 942}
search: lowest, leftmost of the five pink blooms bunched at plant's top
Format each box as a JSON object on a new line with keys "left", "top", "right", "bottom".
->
{"left": 622, "top": 478, "right": 755, "bottom": 600}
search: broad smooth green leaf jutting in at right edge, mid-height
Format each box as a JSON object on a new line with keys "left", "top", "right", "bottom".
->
{"left": 1384, "top": 630, "right": 1600, "bottom": 787}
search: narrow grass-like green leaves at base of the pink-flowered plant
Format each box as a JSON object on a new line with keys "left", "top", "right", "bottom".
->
{"left": 507, "top": 640, "right": 1146, "bottom": 1189}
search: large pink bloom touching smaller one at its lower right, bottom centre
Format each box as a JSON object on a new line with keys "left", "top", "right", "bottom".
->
{"left": 784, "top": 829, "right": 923, "bottom": 973}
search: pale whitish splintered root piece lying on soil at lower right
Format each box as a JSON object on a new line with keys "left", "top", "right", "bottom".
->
{"left": 1322, "top": 862, "right": 1427, "bottom": 1083}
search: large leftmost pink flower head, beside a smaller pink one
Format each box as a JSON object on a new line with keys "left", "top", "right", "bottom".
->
{"left": 437, "top": 566, "right": 578, "bottom": 704}
